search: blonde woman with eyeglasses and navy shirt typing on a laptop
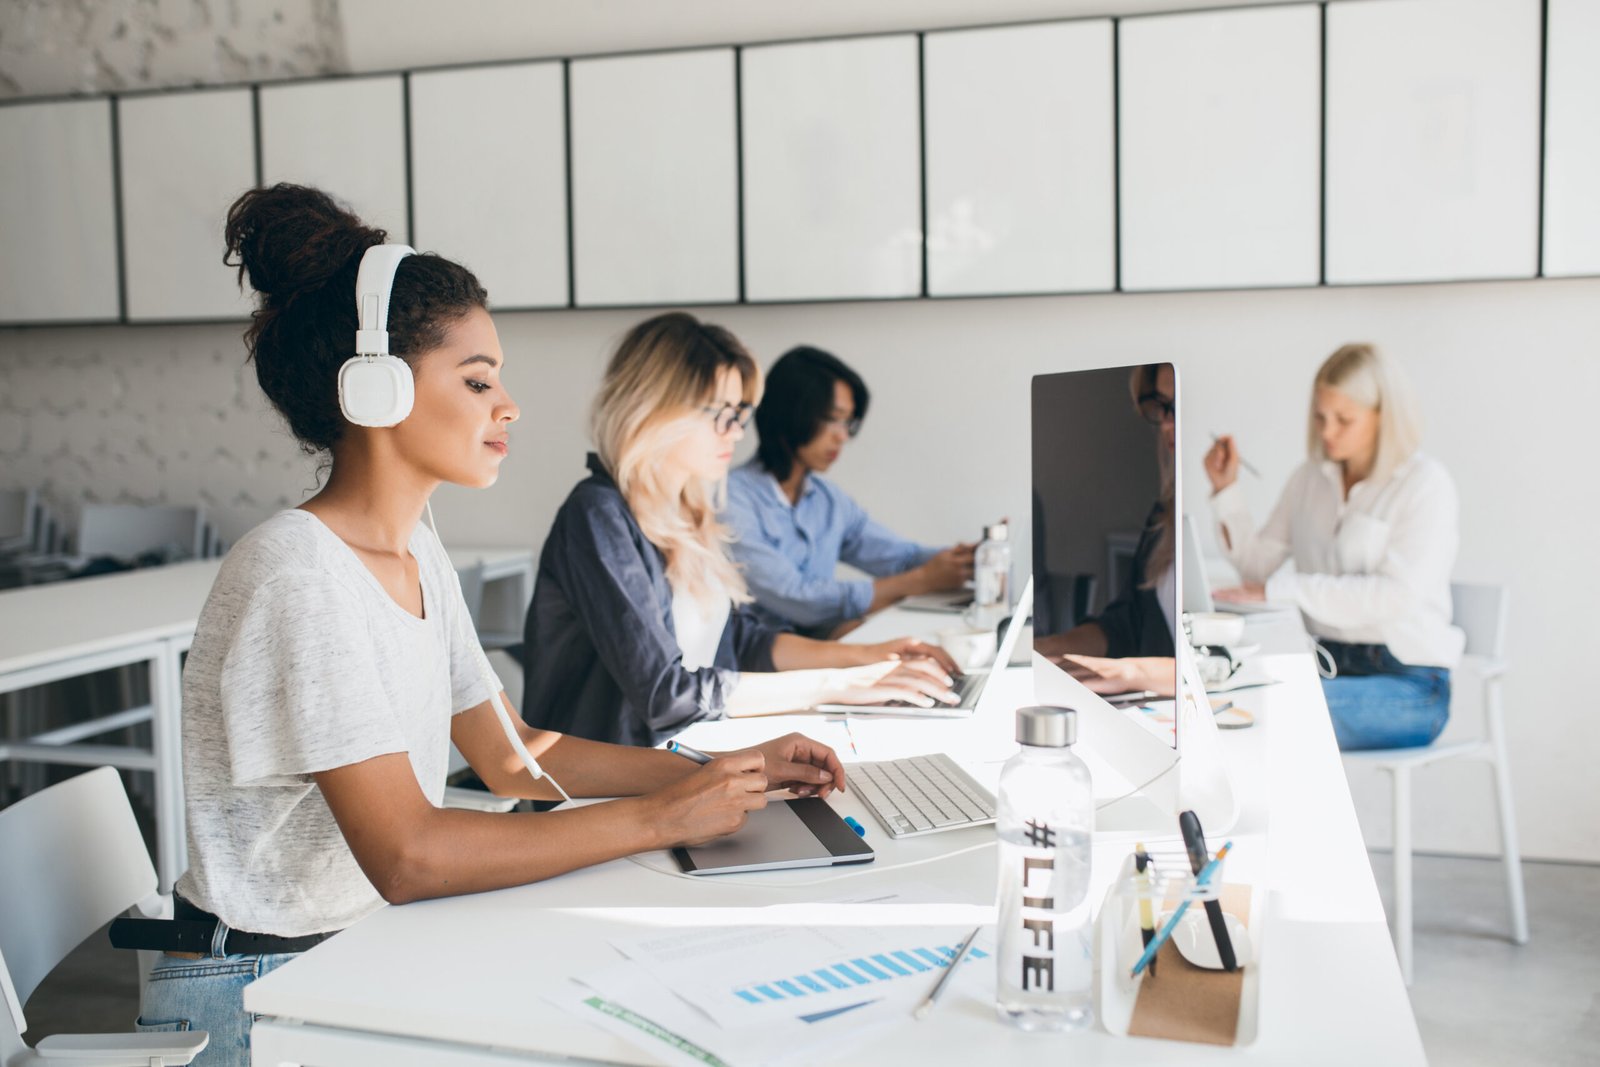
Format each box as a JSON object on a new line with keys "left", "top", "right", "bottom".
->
{"left": 523, "top": 312, "right": 955, "bottom": 745}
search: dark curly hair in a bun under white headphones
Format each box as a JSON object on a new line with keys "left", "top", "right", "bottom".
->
{"left": 222, "top": 184, "right": 488, "bottom": 453}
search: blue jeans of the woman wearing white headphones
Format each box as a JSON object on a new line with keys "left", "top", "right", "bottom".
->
{"left": 134, "top": 923, "right": 299, "bottom": 1067}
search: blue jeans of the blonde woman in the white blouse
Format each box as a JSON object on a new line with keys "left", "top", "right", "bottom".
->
{"left": 1322, "top": 641, "right": 1450, "bottom": 752}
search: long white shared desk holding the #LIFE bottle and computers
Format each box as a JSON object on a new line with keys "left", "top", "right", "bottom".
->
{"left": 245, "top": 613, "right": 1424, "bottom": 1067}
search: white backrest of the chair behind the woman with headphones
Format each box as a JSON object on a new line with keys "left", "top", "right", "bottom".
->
{"left": 0, "top": 766, "right": 155, "bottom": 1033}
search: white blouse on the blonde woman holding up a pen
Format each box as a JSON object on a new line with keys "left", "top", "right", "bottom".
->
{"left": 1211, "top": 453, "right": 1466, "bottom": 667}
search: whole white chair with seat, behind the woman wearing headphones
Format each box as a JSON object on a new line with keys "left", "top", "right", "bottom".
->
{"left": 0, "top": 766, "right": 211, "bottom": 1067}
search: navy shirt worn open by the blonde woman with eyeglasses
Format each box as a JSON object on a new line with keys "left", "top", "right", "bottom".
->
{"left": 522, "top": 453, "right": 779, "bottom": 745}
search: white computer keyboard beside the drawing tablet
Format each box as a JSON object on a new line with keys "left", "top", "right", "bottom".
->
{"left": 846, "top": 752, "right": 995, "bottom": 837}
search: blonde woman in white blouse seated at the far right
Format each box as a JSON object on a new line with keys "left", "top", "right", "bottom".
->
{"left": 1205, "top": 344, "right": 1464, "bottom": 749}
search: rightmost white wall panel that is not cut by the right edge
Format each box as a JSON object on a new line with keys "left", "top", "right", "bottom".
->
{"left": 1326, "top": 0, "right": 1539, "bottom": 283}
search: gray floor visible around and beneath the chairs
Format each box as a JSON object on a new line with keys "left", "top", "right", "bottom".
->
{"left": 15, "top": 853, "right": 1600, "bottom": 1067}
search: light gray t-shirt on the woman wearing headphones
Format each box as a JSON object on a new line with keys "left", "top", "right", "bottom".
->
{"left": 178, "top": 509, "right": 499, "bottom": 937}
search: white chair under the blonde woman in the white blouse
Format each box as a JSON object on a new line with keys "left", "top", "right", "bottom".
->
{"left": 1344, "top": 582, "right": 1528, "bottom": 985}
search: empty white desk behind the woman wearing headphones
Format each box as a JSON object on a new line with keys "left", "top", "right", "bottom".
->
{"left": 0, "top": 547, "right": 533, "bottom": 893}
